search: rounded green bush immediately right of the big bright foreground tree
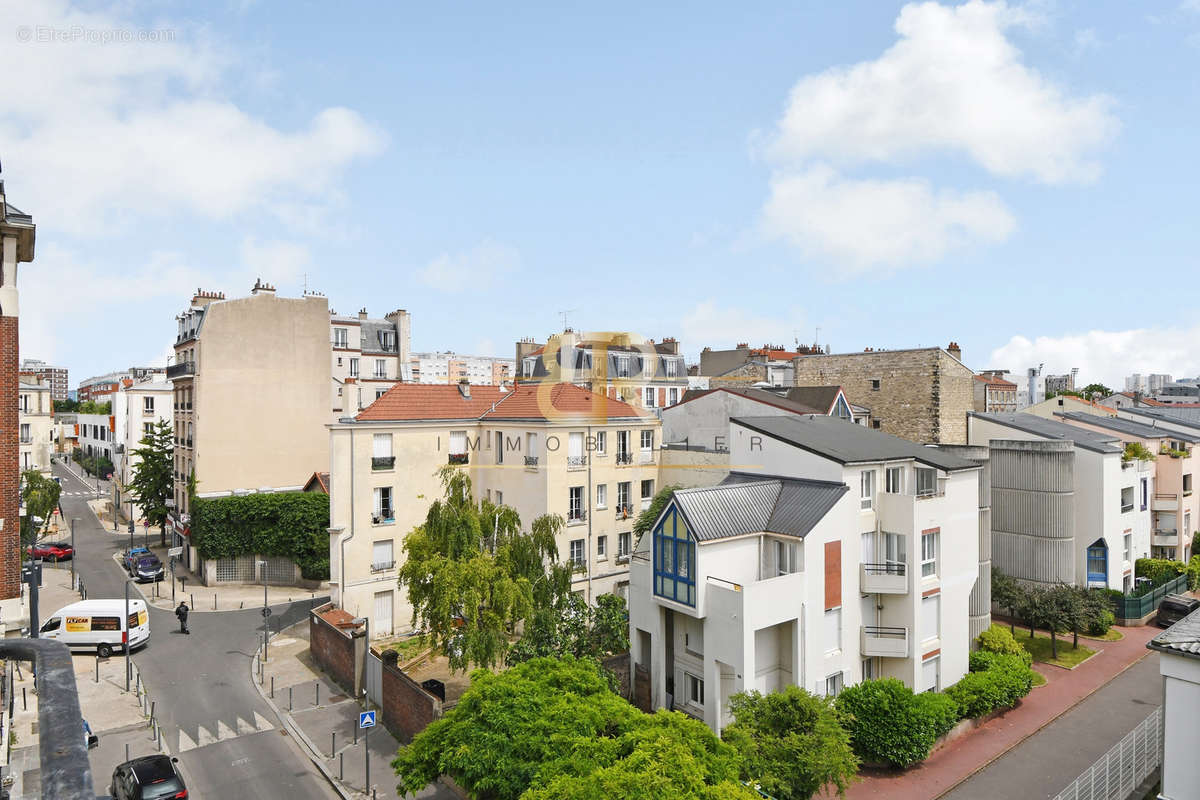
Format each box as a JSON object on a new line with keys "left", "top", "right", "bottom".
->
{"left": 721, "top": 686, "right": 858, "bottom": 800}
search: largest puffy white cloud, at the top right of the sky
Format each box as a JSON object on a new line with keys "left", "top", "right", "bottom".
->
{"left": 770, "top": 0, "right": 1117, "bottom": 184}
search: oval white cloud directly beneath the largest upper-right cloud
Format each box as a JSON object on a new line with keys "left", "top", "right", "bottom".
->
{"left": 763, "top": 166, "right": 1016, "bottom": 275}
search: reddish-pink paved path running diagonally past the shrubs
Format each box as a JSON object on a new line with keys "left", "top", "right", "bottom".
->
{"left": 820, "top": 625, "right": 1160, "bottom": 800}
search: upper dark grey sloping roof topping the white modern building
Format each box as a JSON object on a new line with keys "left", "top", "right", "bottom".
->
{"left": 733, "top": 414, "right": 979, "bottom": 471}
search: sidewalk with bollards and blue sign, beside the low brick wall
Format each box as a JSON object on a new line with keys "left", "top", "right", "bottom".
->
{"left": 252, "top": 620, "right": 460, "bottom": 800}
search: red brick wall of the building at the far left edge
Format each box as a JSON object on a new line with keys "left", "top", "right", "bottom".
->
{"left": 0, "top": 317, "right": 20, "bottom": 600}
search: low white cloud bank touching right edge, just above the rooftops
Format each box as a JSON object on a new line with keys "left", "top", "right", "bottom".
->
{"left": 988, "top": 325, "right": 1200, "bottom": 389}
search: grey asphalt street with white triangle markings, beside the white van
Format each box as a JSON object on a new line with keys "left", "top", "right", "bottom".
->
{"left": 49, "top": 464, "right": 337, "bottom": 800}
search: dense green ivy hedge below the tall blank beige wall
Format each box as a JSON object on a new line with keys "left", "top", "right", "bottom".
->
{"left": 192, "top": 492, "right": 329, "bottom": 581}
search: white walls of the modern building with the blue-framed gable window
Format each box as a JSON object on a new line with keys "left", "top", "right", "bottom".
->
{"left": 630, "top": 421, "right": 979, "bottom": 732}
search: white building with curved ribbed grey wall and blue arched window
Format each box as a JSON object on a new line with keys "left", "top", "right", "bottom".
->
{"left": 967, "top": 413, "right": 1154, "bottom": 591}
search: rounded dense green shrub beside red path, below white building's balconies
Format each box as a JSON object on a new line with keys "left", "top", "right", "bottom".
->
{"left": 836, "top": 678, "right": 958, "bottom": 766}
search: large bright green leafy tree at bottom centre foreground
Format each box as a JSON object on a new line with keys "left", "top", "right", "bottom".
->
{"left": 391, "top": 656, "right": 646, "bottom": 800}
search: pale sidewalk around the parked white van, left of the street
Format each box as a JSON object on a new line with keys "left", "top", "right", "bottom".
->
{"left": 10, "top": 565, "right": 166, "bottom": 798}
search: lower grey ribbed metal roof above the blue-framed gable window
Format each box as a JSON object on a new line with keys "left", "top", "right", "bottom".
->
{"left": 673, "top": 473, "right": 850, "bottom": 542}
